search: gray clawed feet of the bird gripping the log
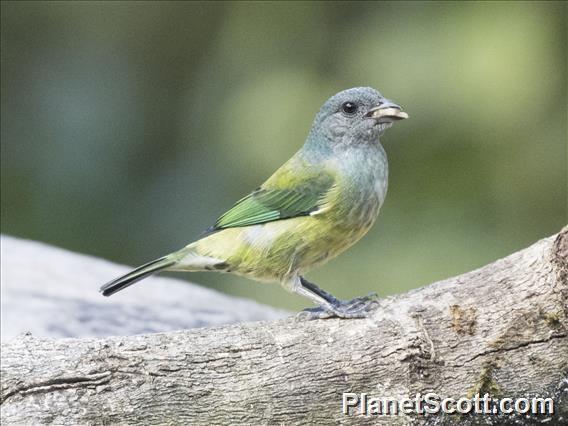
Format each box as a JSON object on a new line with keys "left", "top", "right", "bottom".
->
{"left": 296, "top": 293, "right": 379, "bottom": 321}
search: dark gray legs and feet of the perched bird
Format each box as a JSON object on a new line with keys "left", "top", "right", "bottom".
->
{"left": 294, "top": 276, "right": 379, "bottom": 320}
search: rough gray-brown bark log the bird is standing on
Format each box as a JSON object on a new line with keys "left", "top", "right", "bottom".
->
{"left": 1, "top": 228, "right": 568, "bottom": 424}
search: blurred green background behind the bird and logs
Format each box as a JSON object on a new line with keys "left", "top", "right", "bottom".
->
{"left": 1, "top": 2, "right": 568, "bottom": 309}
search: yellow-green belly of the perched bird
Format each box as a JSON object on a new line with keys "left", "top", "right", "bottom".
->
{"left": 197, "top": 195, "right": 380, "bottom": 281}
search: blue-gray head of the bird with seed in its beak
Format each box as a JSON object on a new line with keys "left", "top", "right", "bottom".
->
{"left": 312, "top": 87, "right": 408, "bottom": 144}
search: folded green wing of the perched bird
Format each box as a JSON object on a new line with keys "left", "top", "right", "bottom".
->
{"left": 207, "top": 166, "right": 335, "bottom": 233}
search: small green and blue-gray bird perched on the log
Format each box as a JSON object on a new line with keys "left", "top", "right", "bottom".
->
{"left": 101, "top": 87, "right": 408, "bottom": 319}
